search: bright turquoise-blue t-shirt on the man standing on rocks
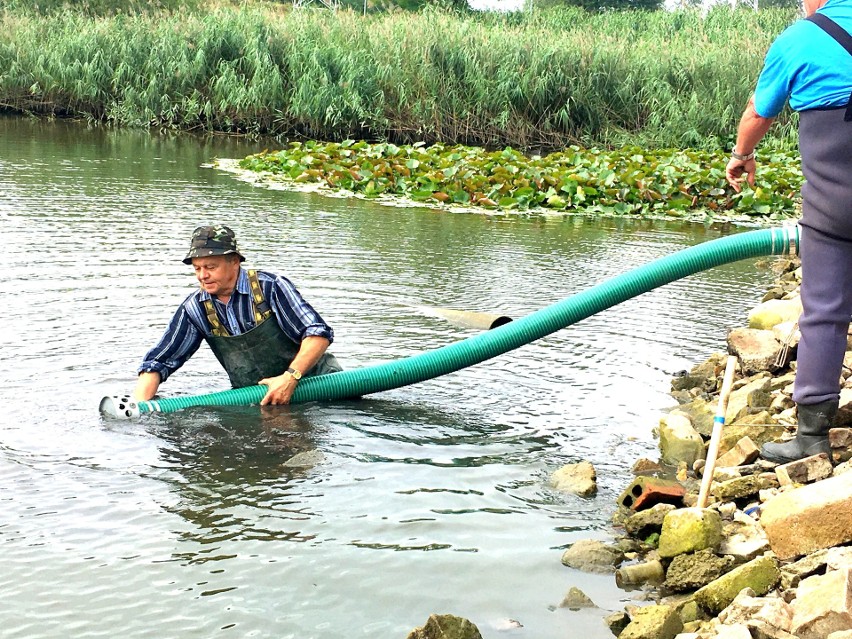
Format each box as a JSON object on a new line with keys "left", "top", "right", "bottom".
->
{"left": 754, "top": 0, "right": 852, "bottom": 118}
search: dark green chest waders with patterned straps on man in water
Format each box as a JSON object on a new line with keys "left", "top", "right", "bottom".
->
{"left": 203, "top": 270, "right": 342, "bottom": 388}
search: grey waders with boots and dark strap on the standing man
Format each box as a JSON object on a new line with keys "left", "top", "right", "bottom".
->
{"left": 760, "top": 14, "right": 852, "bottom": 464}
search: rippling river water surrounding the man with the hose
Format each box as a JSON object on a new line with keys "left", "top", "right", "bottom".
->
{"left": 0, "top": 118, "right": 772, "bottom": 639}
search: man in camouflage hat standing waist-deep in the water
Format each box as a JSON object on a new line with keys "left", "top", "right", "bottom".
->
{"left": 133, "top": 225, "right": 341, "bottom": 405}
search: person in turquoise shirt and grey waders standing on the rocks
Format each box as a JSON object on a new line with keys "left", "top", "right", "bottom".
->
{"left": 726, "top": 0, "right": 852, "bottom": 463}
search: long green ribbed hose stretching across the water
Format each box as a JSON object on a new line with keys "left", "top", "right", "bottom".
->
{"left": 139, "top": 226, "right": 799, "bottom": 413}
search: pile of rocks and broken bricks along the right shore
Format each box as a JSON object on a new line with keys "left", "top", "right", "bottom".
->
{"left": 555, "top": 260, "right": 852, "bottom": 639}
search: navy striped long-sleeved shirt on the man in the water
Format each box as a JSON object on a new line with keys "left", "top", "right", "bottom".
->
{"left": 139, "top": 268, "right": 334, "bottom": 382}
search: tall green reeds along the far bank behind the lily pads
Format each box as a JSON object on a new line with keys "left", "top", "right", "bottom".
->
{"left": 0, "top": 5, "right": 794, "bottom": 150}
